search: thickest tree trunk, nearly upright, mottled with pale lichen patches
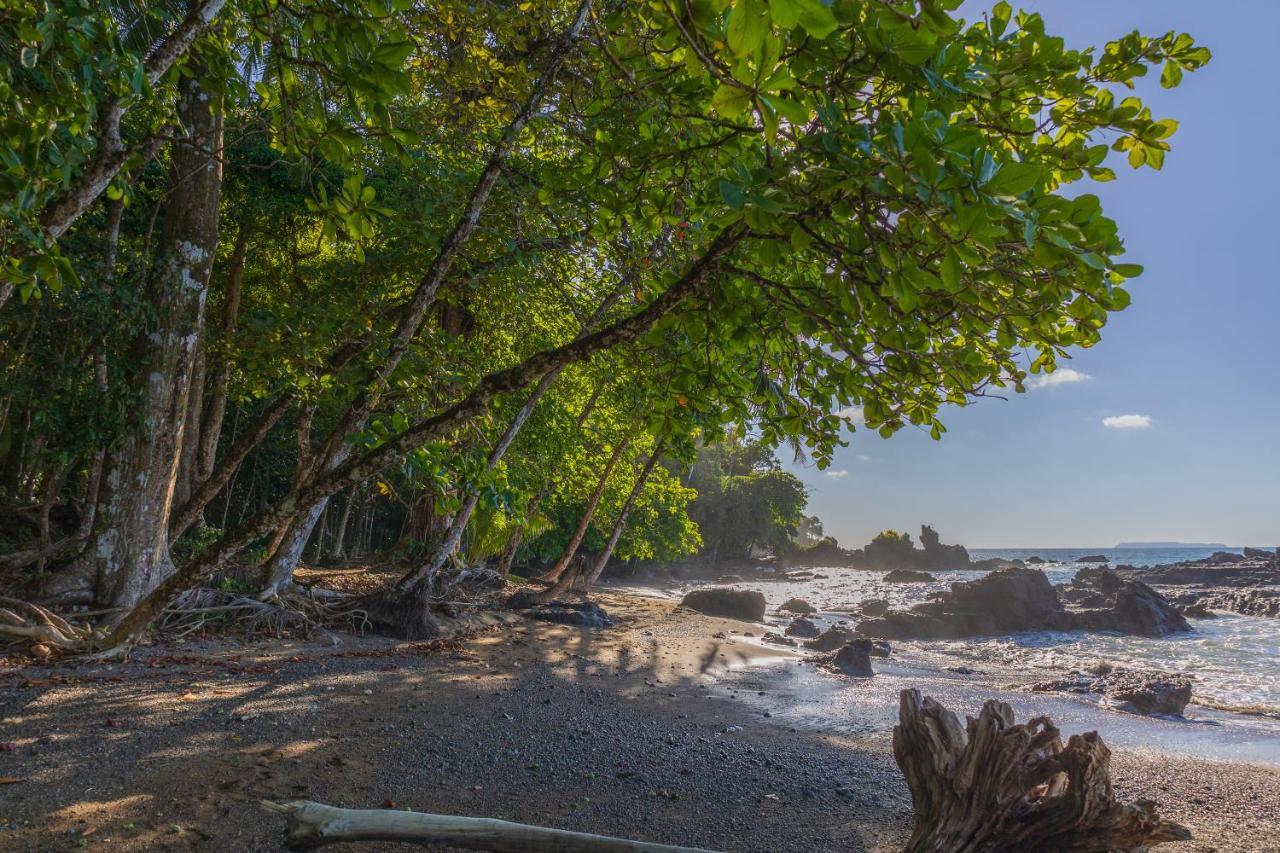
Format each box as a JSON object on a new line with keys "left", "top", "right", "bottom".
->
{"left": 77, "top": 74, "right": 223, "bottom": 607}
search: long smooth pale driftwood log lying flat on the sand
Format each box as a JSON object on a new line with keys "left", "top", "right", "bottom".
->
{"left": 262, "top": 800, "right": 710, "bottom": 853}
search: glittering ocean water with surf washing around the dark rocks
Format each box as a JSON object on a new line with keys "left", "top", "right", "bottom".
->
{"left": 627, "top": 548, "right": 1280, "bottom": 766}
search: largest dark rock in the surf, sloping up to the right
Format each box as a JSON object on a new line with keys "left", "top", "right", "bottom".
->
{"left": 858, "top": 569, "right": 1073, "bottom": 639}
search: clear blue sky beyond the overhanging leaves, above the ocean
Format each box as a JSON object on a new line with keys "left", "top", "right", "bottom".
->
{"left": 783, "top": 0, "right": 1280, "bottom": 548}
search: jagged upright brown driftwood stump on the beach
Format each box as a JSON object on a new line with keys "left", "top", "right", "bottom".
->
{"left": 893, "top": 690, "right": 1190, "bottom": 853}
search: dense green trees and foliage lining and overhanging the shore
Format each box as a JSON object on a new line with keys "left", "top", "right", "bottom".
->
{"left": 0, "top": 0, "right": 1208, "bottom": 643}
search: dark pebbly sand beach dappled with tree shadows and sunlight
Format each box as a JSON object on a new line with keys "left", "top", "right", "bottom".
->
{"left": 0, "top": 593, "right": 1280, "bottom": 852}
